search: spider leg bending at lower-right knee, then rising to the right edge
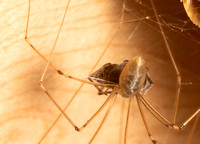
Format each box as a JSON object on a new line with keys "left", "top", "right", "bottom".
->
{"left": 138, "top": 94, "right": 200, "bottom": 130}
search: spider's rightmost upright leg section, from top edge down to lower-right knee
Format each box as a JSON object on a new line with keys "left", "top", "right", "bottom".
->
{"left": 151, "top": 0, "right": 181, "bottom": 123}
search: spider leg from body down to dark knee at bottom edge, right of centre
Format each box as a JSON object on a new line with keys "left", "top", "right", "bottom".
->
{"left": 136, "top": 95, "right": 158, "bottom": 144}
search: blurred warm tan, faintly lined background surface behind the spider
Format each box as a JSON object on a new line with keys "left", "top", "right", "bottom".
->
{"left": 0, "top": 0, "right": 200, "bottom": 144}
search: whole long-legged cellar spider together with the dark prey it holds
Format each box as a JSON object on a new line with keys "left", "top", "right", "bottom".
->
{"left": 25, "top": 0, "right": 200, "bottom": 144}
